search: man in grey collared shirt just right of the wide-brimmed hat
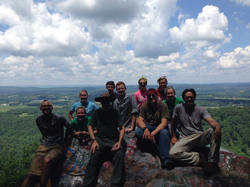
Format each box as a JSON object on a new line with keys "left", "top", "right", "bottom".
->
{"left": 113, "top": 81, "right": 138, "bottom": 133}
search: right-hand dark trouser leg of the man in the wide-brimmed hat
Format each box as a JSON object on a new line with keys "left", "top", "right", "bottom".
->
{"left": 110, "top": 149, "right": 126, "bottom": 187}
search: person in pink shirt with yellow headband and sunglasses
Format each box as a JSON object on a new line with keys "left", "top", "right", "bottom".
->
{"left": 134, "top": 76, "right": 148, "bottom": 110}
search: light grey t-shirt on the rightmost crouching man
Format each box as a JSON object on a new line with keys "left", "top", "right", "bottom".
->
{"left": 173, "top": 103, "right": 211, "bottom": 138}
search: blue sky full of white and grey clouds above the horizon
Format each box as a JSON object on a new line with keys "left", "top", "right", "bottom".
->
{"left": 0, "top": 0, "right": 250, "bottom": 86}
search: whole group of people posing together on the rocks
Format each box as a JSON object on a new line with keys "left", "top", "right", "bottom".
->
{"left": 22, "top": 76, "right": 221, "bottom": 187}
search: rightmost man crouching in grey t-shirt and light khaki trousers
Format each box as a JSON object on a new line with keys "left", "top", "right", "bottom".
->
{"left": 169, "top": 89, "right": 221, "bottom": 175}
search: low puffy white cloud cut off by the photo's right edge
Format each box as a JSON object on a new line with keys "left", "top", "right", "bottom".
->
{"left": 216, "top": 46, "right": 250, "bottom": 69}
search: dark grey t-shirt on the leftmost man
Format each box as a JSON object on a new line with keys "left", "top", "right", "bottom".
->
{"left": 36, "top": 113, "right": 68, "bottom": 147}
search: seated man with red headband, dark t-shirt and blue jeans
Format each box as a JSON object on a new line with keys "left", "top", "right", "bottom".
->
{"left": 135, "top": 88, "right": 174, "bottom": 170}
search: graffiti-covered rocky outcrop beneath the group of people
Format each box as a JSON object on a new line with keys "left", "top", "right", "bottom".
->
{"left": 59, "top": 133, "right": 250, "bottom": 187}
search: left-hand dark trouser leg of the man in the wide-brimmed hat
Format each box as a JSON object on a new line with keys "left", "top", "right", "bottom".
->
{"left": 83, "top": 144, "right": 105, "bottom": 187}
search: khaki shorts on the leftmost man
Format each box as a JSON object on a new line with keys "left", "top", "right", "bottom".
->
{"left": 28, "top": 144, "right": 64, "bottom": 176}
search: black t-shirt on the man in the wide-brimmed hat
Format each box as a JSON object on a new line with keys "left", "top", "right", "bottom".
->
{"left": 89, "top": 108, "right": 123, "bottom": 147}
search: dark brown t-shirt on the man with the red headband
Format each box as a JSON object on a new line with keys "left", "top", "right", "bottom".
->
{"left": 140, "top": 101, "right": 169, "bottom": 126}
